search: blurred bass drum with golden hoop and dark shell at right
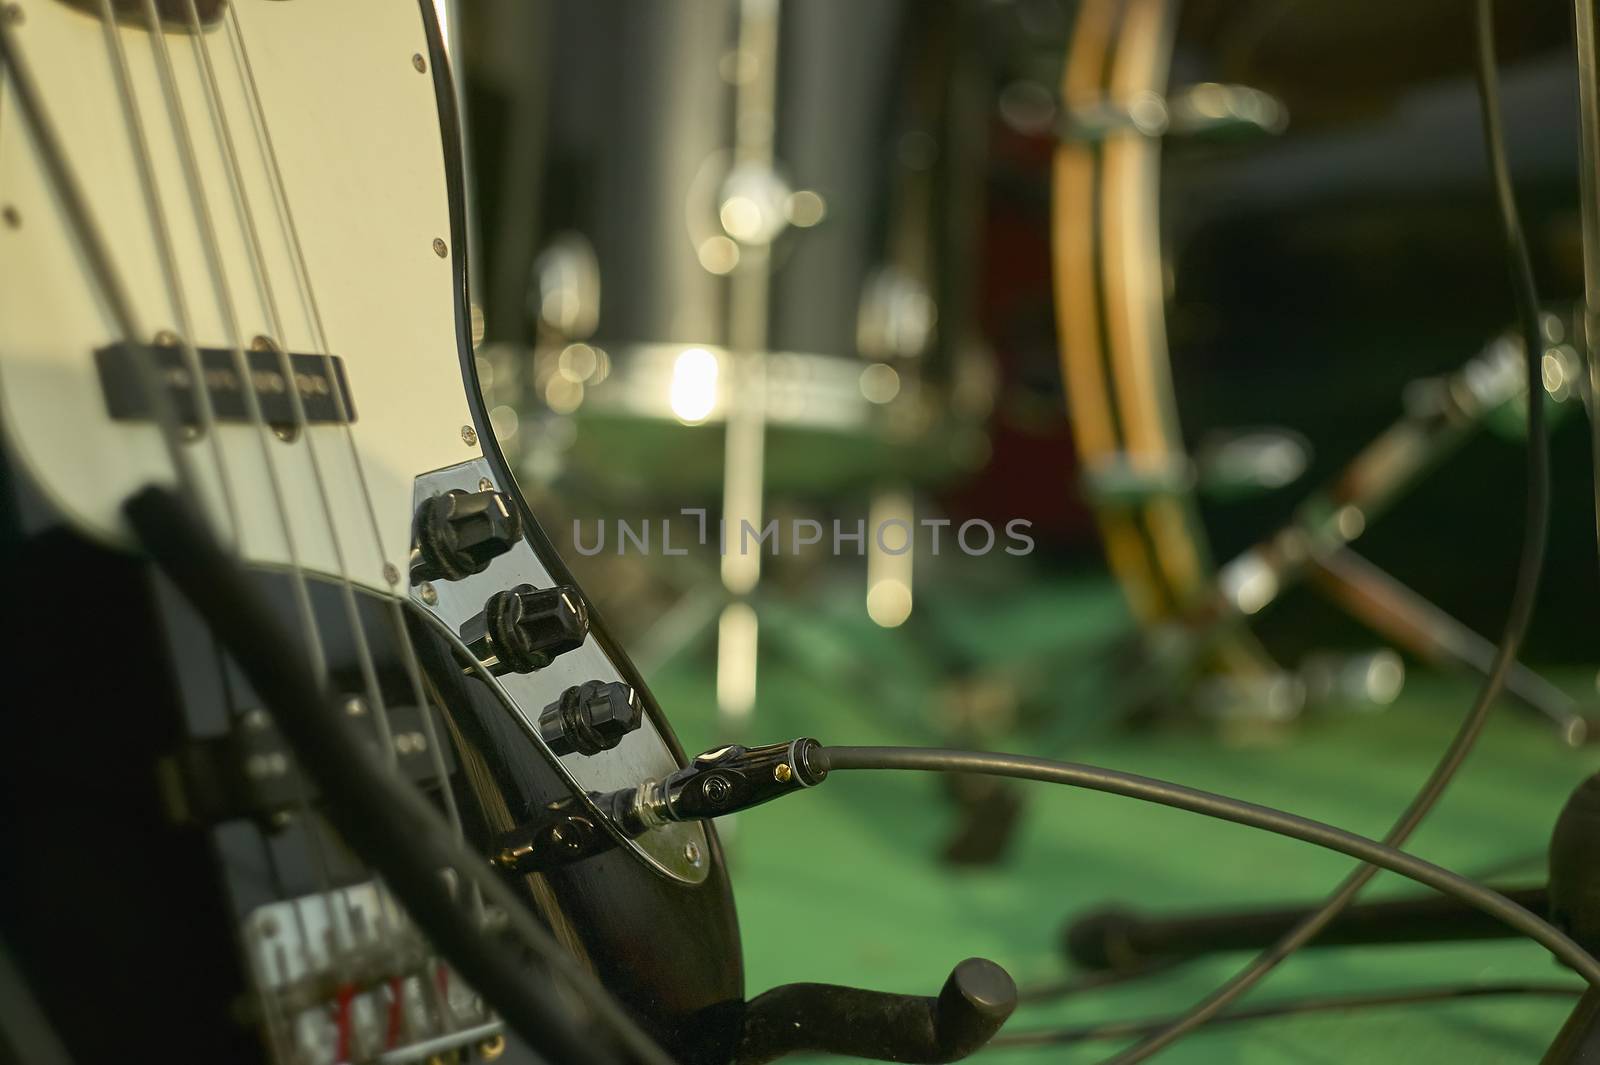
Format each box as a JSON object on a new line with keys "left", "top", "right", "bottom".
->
{"left": 1051, "top": 0, "right": 1595, "bottom": 729}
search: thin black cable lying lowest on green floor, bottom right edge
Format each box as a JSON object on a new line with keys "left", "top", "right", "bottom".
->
{"left": 989, "top": 983, "right": 1582, "bottom": 1049}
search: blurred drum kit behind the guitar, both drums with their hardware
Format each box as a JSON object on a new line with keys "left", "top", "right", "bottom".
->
{"left": 464, "top": 0, "right": 1587, "bottom": 744}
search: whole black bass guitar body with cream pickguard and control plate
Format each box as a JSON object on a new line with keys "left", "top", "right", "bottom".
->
{"left": 0, "top": 0, "right": 742, "bottom": 1065}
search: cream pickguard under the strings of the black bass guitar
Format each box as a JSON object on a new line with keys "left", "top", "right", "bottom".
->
{"left": 0, "top": 0, "right": 480, "bottom": 590}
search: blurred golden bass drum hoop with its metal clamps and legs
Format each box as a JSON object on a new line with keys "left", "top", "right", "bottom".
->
{"left": 1054, "top": 0, "right": 1586, "bottom": 729}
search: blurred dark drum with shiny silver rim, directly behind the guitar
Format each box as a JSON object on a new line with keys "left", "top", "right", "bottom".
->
{"left": 469, "top": 0, "right": 989, "bottom": 493}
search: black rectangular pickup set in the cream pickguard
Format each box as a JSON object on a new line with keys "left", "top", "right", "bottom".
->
{"left": 94, "top": 342, "right": 355, "bottom": 429}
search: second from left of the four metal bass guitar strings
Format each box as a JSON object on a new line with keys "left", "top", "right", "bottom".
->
{"left": 131, "top": 0, "right": 363, "bottom": 997}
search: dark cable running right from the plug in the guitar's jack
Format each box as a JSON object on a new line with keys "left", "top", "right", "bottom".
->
{"left": 821, "top": 747, "right": 1600, "bottom": 988}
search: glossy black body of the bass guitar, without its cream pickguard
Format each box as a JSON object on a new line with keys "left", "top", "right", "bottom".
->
{"left": 0, "top": 0, "right": 744, "bottom": 1065}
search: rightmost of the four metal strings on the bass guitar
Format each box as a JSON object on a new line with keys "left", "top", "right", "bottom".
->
{"left": 227, "top": 5, "right": 493, "bottom": 940}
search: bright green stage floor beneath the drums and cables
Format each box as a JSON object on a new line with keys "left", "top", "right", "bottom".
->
{"left": 651, "top": 575, "right": 1600, "bottom": 1065}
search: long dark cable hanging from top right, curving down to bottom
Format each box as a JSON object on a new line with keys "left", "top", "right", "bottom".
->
{"left": 1088, "top": 0, "right": 1550, "bottom": 1065}
